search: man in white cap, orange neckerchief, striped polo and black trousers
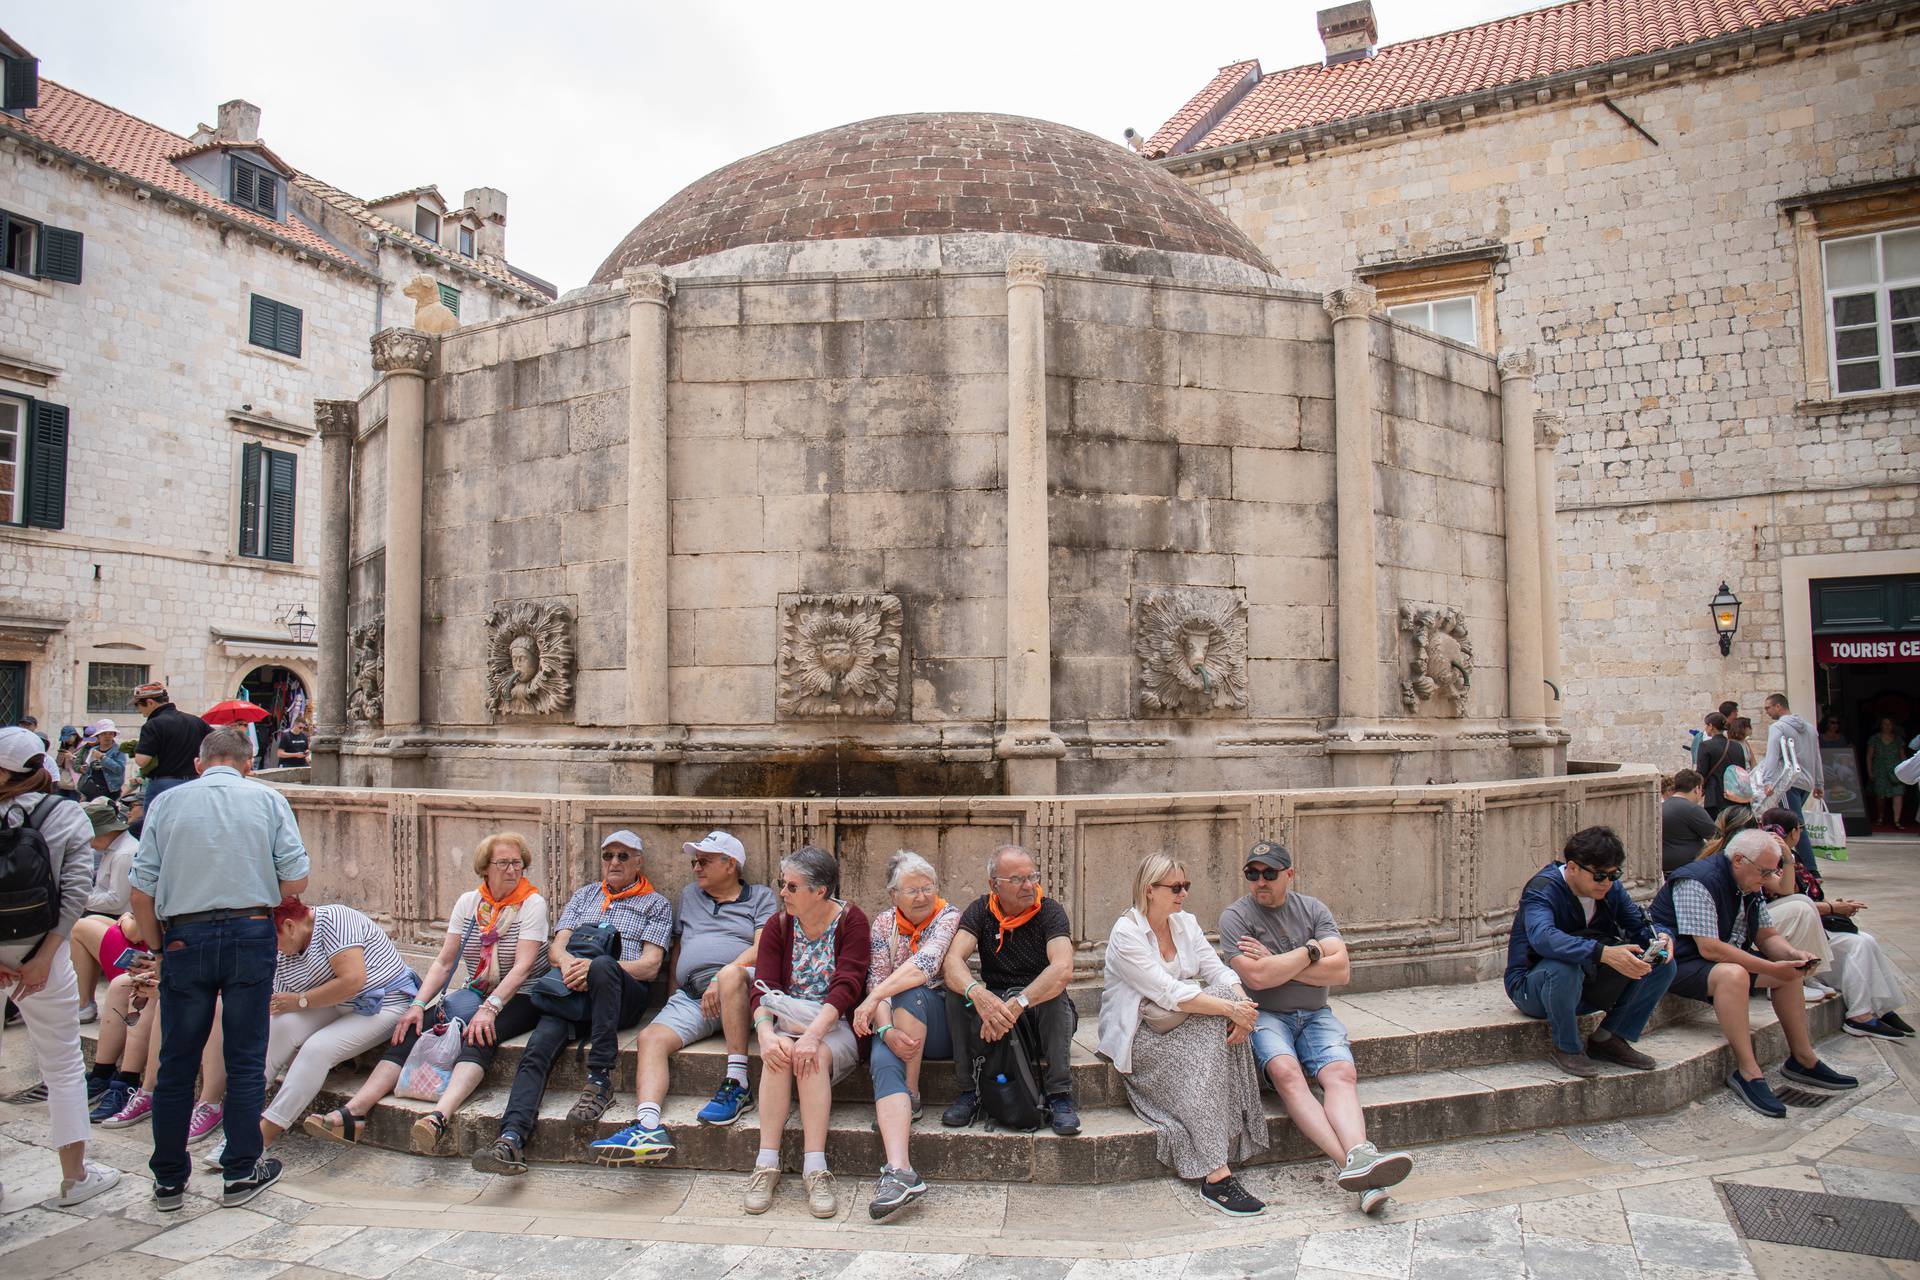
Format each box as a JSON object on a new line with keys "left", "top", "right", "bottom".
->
{"left": 472, "top": 829, "right": 674, "bottom": 1174}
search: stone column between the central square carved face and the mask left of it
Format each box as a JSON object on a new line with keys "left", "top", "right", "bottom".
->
{"left": 622, "top": 265, "right": 674, "bottom": 794}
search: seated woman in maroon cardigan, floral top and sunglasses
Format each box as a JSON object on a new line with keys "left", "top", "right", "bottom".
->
{"left": 745, "top": 844, "right": 874, "bottom": 1219}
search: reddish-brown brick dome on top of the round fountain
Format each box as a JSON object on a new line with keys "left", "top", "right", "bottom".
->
{"left": 593, "top": 113, "right": 1273, "bottom": 284}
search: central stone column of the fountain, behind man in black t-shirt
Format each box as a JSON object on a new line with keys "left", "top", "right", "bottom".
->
{"left": 995, "top": 255, "right": 1066, "bottom": 794}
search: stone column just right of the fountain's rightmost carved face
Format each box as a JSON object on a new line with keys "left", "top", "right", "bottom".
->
{"left": 1500, "top": 347, "right": 1546, "bottom": 756}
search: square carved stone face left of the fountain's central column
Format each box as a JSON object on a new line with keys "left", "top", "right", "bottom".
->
{"left": 778, "top": 593, "right": 902, "bottom": 718}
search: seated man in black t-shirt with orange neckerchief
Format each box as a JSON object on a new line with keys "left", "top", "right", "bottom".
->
{"left": 941, "top": 844, "right": 1079, "bottom": 1136}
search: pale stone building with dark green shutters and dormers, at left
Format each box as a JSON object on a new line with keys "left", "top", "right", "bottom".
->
{"left": 0, "top": 38, "right": 553, "bottom": 733}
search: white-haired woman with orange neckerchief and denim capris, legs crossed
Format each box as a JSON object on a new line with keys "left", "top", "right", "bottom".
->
{"left": 852, "top": 848, "right": 960, "bottom": 1219}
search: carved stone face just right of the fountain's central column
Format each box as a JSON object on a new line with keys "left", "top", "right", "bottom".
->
{"left": 1133, "top": 587, "right": 1246, "bottom": 716}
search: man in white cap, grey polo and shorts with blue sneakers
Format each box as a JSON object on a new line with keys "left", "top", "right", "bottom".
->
{"left": 591, "top": 831, "right": 780, "bottom": 1165}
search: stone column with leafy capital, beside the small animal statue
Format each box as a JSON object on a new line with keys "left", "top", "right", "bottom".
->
{"left": 372, "top": 328, "right": 436, "bottom": 767}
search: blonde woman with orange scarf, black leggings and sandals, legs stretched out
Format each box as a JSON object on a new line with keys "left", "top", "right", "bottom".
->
{"left": 305, "top": 831, "right": 549, "bottom": 1155}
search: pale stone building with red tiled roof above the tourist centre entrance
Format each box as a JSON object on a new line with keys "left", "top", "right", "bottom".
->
{"left": 1146, "top": 0, "right": 1920, "bottom": 762}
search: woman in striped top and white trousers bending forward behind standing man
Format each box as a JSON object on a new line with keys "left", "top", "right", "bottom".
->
{"left": 204, "top": 898, "right": 420, "bottom": 1169}
